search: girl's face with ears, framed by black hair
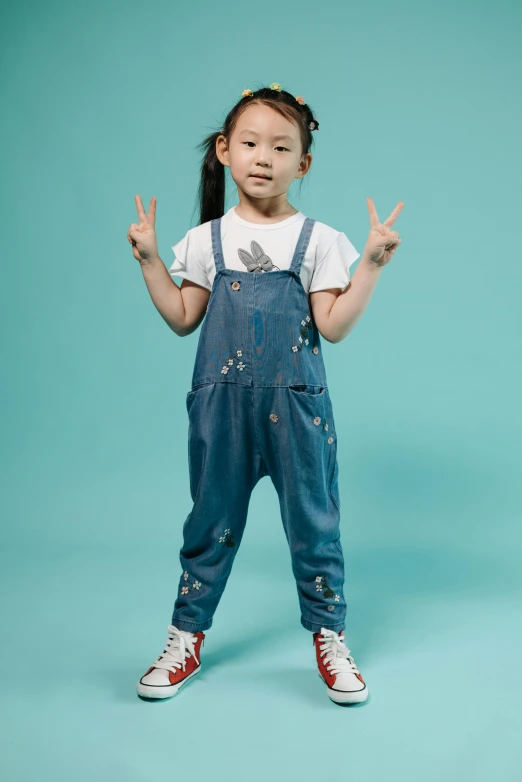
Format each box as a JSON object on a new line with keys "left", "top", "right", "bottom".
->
{"left": 216, "top": 103, "right": 312, "bottom": 199}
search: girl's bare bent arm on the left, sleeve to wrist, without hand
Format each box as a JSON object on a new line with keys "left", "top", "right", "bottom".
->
{"left": 140, "top": 255, "right": 210, "bottom": 337}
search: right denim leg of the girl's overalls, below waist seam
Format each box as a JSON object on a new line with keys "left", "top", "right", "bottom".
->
{"left": 255, "top": 386, "right": 346, "bottom": 632}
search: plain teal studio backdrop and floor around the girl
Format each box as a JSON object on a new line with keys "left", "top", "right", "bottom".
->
{"left": 0, "top": 0, "right": 522, "bottom": 782}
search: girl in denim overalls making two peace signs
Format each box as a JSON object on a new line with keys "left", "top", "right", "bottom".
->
{"left": 128, "top": 83, "right": 404, "bottom": 703}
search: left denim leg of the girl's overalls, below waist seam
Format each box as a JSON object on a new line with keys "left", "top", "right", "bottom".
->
{"left": 172, "top": 383, "right": 267, "bottom": 632}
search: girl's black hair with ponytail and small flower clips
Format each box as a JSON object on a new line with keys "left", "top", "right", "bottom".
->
{"left": 197, "top": 87, "right": 319, "bottom": 225}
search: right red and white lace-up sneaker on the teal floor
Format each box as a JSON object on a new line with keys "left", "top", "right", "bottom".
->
{"left": 314, "top": 627, "right": 368, "bottom": 703}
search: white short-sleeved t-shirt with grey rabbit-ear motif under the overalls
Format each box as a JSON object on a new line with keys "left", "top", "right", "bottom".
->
{"left": 169, "top": 206, "right": 360, "bottom": 293}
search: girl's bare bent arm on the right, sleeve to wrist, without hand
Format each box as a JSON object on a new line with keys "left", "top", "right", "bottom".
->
{"left": 310, "top": 252, "right": 383, "bottom": 342}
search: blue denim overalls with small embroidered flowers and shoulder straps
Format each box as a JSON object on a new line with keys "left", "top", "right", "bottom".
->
{"left": 172, "top": 218, "right": 346, "bottom": 632}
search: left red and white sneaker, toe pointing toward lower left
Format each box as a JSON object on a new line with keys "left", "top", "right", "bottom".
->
{"left": 136, "top": 625, "right": 205, "bottom": 698}
